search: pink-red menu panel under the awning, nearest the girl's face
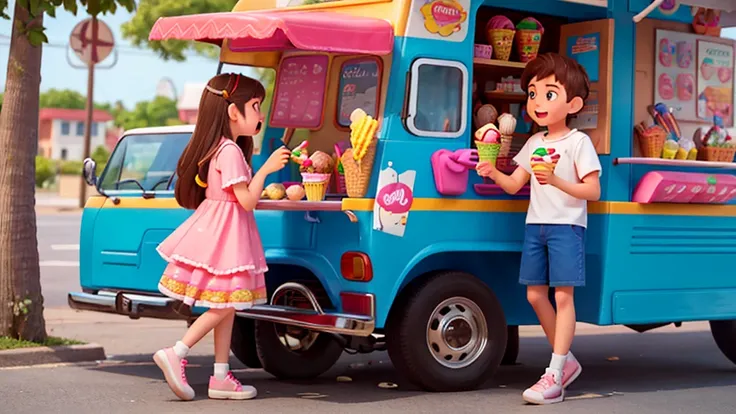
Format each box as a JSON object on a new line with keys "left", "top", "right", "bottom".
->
{"left": 271, "top": 55, "right": 329, "bottom": 128}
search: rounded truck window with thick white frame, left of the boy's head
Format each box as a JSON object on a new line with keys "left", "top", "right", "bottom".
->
{"left": 406, "top": 58, "right": 468, "bottom": 138}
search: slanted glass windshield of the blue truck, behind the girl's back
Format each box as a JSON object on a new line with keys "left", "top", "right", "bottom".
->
{"left": 100, "top": 133, "right": 191, "bottom": 192}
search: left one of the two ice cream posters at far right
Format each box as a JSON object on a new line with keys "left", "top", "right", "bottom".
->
{"left": 654, "top": 30, "right": 699, "bottom": 122}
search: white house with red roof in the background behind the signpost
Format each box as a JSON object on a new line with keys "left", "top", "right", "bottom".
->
{"left": 38, "top": 108, "right": 112, "bottom": 161}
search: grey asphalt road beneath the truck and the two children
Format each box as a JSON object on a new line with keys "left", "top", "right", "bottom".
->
{"left": 10, "top": 214, "right": 736, "bottom": 414}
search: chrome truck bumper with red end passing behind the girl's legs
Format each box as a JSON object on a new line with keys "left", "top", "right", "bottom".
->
{"left": 68, "top": 282, "right": 375, "bottom": 336}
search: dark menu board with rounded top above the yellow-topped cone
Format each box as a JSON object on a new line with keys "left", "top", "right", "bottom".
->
{"left": 337, "top": 58, "right": 381, "bottom": 127}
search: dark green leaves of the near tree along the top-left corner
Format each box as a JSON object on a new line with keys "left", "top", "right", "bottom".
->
{"left": 0, "top": 0, "right": 135, "bottom": 46}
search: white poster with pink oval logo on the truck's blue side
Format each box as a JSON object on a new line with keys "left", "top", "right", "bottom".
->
{"left": 373, "top": 162, "right": 417, "bottom": 237}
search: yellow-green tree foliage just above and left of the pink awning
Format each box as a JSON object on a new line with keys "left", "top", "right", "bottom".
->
{"left": 120, "top": 0, "right": 238, "bottom": 61}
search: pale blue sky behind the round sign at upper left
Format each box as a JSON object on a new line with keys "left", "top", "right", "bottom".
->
{"left": 0, "top": 0, "right": 217, "bottom": 107}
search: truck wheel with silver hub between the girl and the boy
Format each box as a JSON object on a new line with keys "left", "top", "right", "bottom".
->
{"left": 386, "top": 271, "right": 507, "bottom": 391}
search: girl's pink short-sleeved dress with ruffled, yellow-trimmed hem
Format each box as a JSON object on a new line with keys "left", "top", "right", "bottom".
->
{"left": 157, "top": 138, "right": 268, "bottom": 310}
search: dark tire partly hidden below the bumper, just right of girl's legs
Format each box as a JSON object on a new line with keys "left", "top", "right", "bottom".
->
{"left": 255, "top": 321, "right": 343, "bottom": 380}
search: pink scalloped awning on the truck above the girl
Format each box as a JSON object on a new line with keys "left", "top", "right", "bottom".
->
{"left": 148, "top": 11, "right": 394, "bottom": 55}
